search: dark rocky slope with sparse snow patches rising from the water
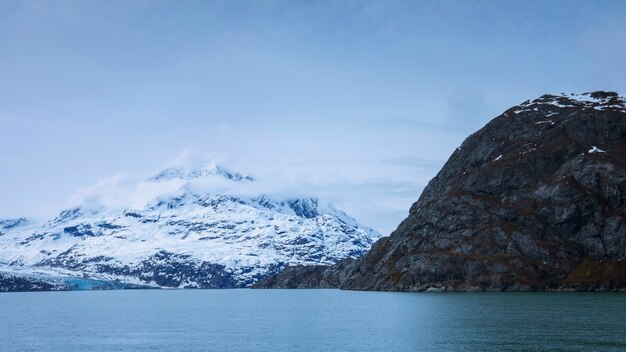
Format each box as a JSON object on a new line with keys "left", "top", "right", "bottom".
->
{"left": 252, "top": 92, "right": 626, "bottom": 291}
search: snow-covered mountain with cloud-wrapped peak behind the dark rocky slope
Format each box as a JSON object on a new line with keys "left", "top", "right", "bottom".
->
{"left": 0, "top": 165, "right": 380, "bottom": 289}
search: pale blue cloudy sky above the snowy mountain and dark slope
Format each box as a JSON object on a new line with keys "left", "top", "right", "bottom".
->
{"left": 0, "top": 0, "right": 626, "bottom": 234}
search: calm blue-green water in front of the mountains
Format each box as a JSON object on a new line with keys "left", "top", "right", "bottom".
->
{"left": 0, "top": 290, "right": 626, "bottom": 352}
